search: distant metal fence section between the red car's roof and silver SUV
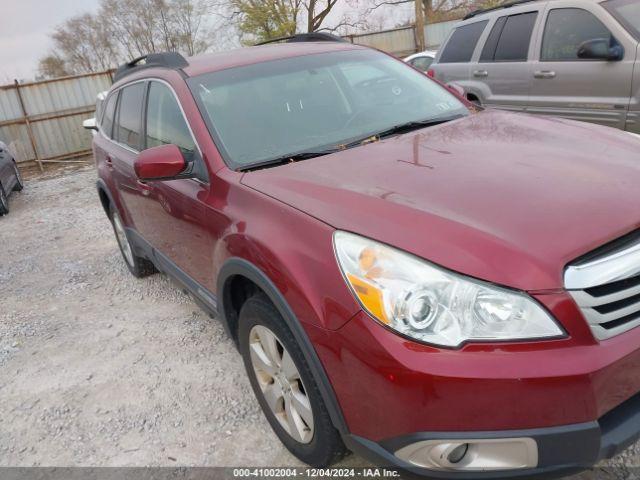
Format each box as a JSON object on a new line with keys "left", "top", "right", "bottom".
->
{"left": 346, "top": 20, "right": 458, "bottom": 57}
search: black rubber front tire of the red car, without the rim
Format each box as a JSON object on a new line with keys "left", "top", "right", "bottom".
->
{"left": 238, "top": 295, "right": 344, "bottom": 467}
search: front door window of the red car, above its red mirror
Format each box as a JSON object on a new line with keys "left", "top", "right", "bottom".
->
{"left": 147, "top": 82, "right": 195, "bottom": 154}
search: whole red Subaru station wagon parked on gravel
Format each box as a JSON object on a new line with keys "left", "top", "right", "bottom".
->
{"left": 94, "top": 37, "right": 640, "bottom": 478}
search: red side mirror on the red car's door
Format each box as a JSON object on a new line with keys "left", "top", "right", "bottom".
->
{"left": 133, "top": 145, "right": 186, "bottom": 181}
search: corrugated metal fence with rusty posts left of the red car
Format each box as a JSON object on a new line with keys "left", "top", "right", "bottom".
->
{"left": 0, "top": 71, "right": 112, "bottom": 167}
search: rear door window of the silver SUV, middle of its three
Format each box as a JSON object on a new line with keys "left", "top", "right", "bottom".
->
{"left": 480, "top": 12, "right": 538, "bottom": 62}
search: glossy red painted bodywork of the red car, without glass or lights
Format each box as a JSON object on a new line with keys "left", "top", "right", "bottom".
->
{"left": 94, "top": 44, "right": 640, "bottom": 440}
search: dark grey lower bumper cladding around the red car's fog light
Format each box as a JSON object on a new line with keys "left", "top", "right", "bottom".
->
{"left": 345, "top": 388, "right": 640, "bottom": 479}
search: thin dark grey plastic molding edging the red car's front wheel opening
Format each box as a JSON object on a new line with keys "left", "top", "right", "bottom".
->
{"left": 217, "top": 258, "right": 349, "bottom": 435}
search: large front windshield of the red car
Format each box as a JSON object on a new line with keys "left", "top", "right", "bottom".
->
{"left": 188, "top": 50, "right": 469, "bottom": 168}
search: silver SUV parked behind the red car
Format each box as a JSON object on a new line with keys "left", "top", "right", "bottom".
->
{"left": 429, "top": 0, "right": 640, "bottom": 133}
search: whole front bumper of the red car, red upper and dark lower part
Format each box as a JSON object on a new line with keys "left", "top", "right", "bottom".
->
{"left": 307, "top": 292, "right": 640, "bottom": 478}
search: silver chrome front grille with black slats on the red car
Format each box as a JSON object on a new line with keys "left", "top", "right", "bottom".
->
{"left": 565, "top": 232, "right": 640, "bottom": 340}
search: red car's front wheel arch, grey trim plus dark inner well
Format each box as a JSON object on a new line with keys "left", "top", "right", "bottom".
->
{"left": 217, "top": 257, "right": 348, "bottom": 434}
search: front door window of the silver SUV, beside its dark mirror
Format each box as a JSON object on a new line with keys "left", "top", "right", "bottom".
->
{"left": 540, "top": 8, "right": 616, "bottom": 62}
